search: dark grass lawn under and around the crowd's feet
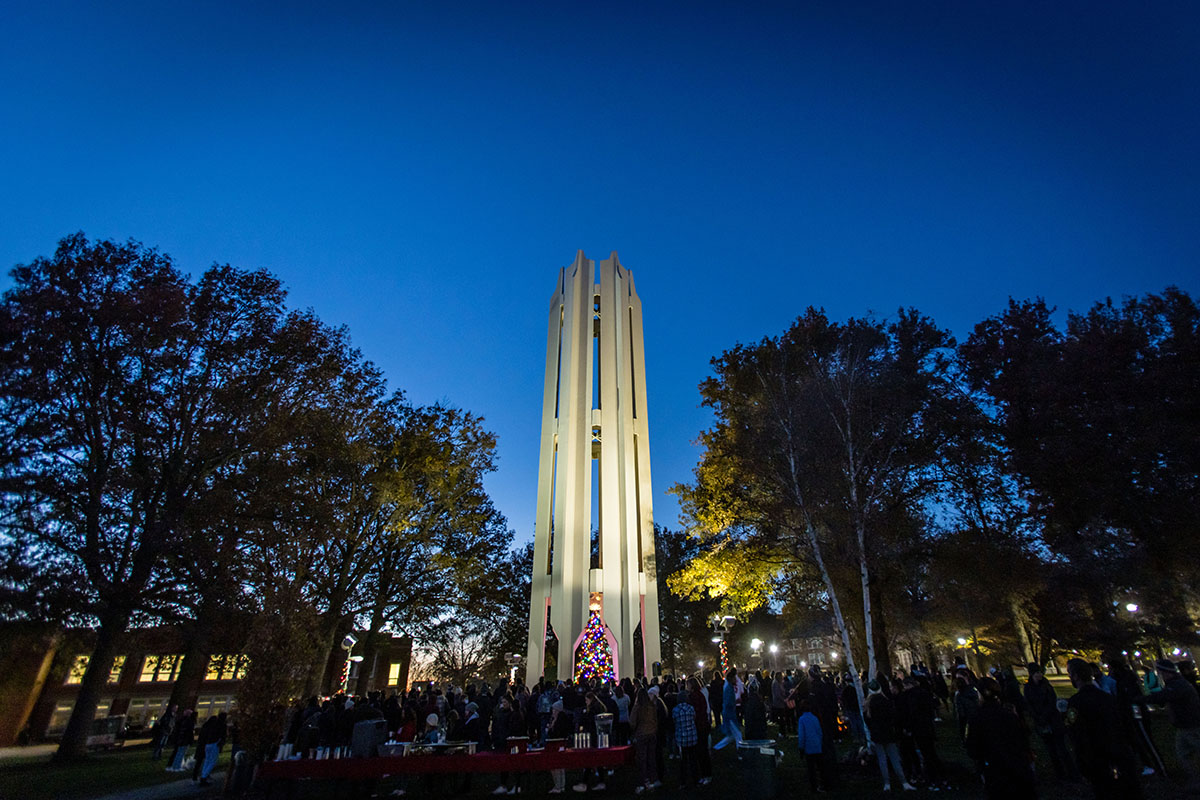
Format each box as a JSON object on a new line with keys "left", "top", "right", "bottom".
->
{"left": 0, "top": 711, "right": 1183, "bottom": 800}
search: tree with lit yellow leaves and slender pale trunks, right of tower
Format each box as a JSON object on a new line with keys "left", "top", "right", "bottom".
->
{"left": 676, "top": 309, "right": 953, "bottom": 743}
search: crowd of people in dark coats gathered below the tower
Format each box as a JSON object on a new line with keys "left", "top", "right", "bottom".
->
{"left": 147, "top": 657, "right": 1200, "bottom": 798}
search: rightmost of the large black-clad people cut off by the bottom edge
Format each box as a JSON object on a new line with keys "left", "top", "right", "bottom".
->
{"left": 1060, "top": 658, "right": 1141, "bottom": 798}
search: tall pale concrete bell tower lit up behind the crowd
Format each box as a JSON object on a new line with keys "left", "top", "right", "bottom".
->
{"left": 526, "top": 251, "right": 661, "bottom": 680}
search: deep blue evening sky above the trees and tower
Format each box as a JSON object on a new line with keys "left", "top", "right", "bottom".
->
{"left": 0, "top": 0, "right": 1200, "bottom": 540}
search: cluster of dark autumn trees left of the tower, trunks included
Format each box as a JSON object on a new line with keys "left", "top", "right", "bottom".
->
{"left": 0, "top": 234, "right": 511, "bottom": 757}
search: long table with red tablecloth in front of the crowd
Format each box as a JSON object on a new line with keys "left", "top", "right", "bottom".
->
{"left": 258, "top": 747, "right": 634, "bottom": 781}
